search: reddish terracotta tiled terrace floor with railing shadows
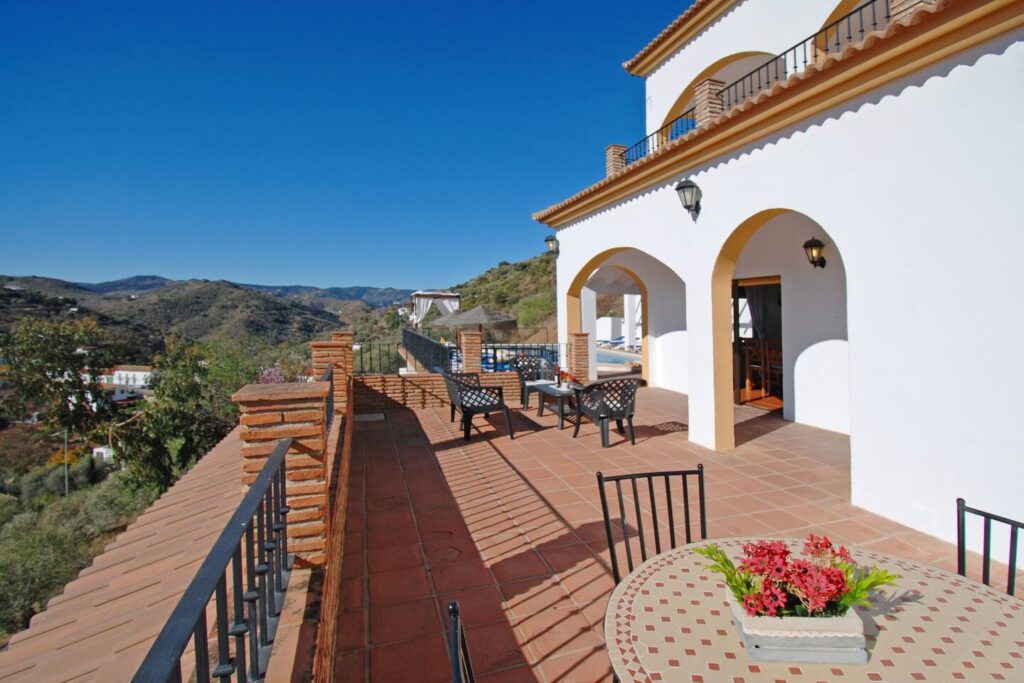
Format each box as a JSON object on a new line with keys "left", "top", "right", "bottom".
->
{"left": 336, "top": 388, "right": 974, "bottom": 683}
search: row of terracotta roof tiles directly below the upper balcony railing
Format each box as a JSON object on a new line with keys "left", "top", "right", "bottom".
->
{"left": 532, "top": 0, "right": 955, "bottom": 223}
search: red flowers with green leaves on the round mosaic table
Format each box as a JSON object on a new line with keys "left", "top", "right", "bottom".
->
{"left": 693, "top": 533, "right": 900, "bottom": 616}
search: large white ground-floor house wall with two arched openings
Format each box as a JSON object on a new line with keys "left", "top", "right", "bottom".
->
{"left": 558, "top": 33, "right": 1024, "bottom": 540}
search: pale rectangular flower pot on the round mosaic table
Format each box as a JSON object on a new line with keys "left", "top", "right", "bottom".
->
{"left": 726, "top": 592, "right": 867, "bottom": 664}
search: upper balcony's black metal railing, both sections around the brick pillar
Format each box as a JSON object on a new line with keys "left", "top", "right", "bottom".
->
{"left": 622, "top": 0, "right": 892, "bottom": 166}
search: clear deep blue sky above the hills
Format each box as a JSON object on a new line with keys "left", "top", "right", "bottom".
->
{"left": 0, "top": 0, "right": 690, "bottom": 288}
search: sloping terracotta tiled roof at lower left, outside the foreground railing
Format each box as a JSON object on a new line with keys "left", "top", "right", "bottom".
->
{"left": 0, "top": 428, "right": 243, "bottom": 683}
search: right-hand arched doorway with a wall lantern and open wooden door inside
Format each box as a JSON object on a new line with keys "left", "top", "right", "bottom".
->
{"left": 712, "top": 209, "right": 850, "bottom": 447}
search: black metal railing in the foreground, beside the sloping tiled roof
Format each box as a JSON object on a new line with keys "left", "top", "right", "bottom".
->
{"left": 132, "top": 438, "right": 293, "bottom": 683}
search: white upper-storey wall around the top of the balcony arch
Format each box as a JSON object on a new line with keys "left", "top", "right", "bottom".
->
{"left": 645, "top": 0, "right": 839, "bottom": 135}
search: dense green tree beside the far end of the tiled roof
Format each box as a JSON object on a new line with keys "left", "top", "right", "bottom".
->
{"left": 111, "top": 338, "right": 231, "bottom": 490}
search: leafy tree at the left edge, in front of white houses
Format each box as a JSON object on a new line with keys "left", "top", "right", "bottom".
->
{"left": 0, "top": 318, "right": 110, "bottom": 434}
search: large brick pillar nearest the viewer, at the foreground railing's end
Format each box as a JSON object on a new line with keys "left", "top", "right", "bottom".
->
{"left": 231, "top": 382, "right": 331, "bottom": 565}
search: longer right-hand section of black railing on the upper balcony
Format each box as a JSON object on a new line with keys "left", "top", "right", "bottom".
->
{"left": 719, "top": 0, "right": 892, "bottom": 112}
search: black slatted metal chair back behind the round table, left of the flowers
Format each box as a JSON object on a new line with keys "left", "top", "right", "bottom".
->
{"left": 597, "top": 465, "right": 708, "bottom": 585}
